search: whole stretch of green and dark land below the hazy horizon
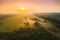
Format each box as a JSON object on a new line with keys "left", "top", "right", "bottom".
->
{"left": 0, "top": 13, "right": 60, "bottom": 40}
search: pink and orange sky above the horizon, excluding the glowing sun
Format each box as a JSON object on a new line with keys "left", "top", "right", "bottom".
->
{"left": 0, "top": 0, "right": 60, "bottom": 13}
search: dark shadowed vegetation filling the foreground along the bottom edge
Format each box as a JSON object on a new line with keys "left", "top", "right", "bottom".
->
{"left": 0, "top": 22, "right": 60, "bottom": 40}
